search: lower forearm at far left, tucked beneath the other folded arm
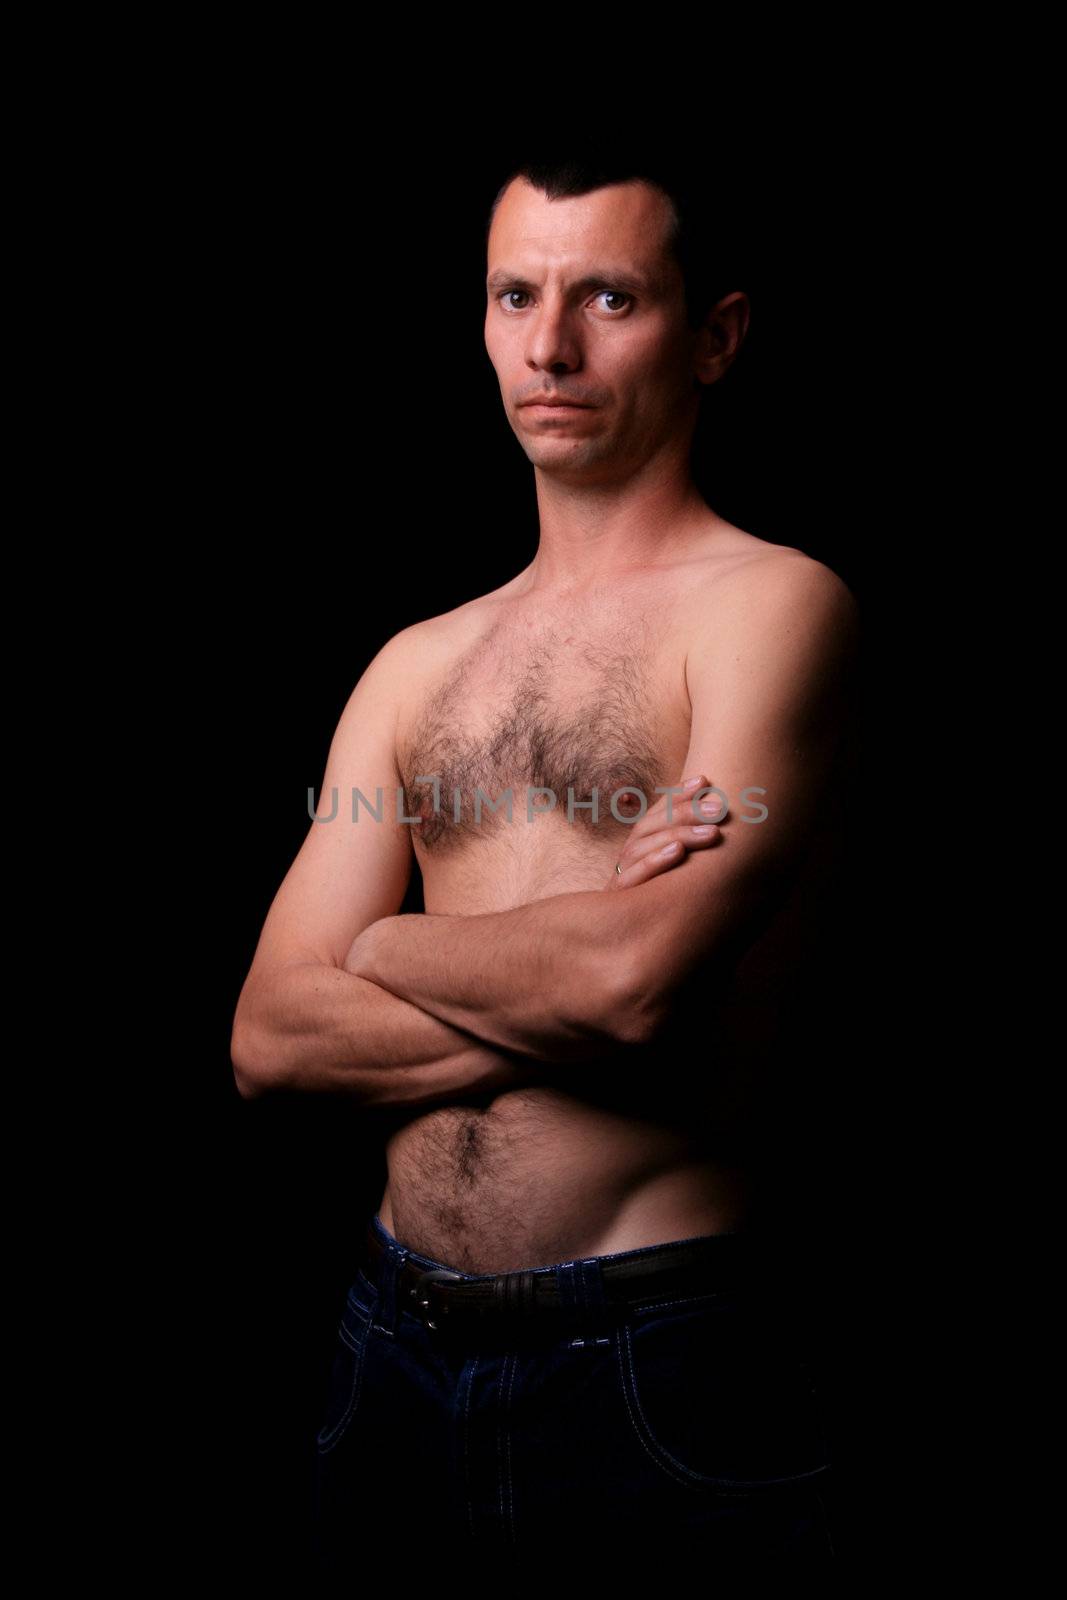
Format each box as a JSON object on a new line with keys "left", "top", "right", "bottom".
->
{"left": 232, "top": 962, "right": 534, "bottom": 1107}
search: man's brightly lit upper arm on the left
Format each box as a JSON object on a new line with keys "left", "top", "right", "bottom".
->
{"left": 241, "top": 634, "right": 413, "bottom": 978}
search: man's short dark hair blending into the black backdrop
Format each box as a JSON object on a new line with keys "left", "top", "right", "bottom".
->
{"left": 485, "top": 152, "right": 744, "bottom": 330}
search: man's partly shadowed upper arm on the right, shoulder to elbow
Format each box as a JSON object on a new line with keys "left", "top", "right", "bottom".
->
{"left": 624, "top": 558, "right": 859, "bottom": 1002}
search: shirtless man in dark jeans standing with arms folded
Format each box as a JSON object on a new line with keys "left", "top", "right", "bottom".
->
{"left": 232, "top": 163, "right": 857, "bottom": 1562}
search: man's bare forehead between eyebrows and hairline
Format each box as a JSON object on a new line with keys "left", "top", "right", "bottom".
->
{"left": 488, "top": 178, "right": 673, "bottom": 278}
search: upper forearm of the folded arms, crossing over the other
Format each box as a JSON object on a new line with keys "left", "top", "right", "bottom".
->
{"left": 346, "top": 891, "right": 637, "bottom": 1062}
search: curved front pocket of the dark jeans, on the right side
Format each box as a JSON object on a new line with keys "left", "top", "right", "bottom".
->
{"left": 619, "top": 1294, "right": 830, "bottom": 1493}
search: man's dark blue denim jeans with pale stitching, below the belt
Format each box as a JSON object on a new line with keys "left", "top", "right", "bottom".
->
{"left": 314, "top": 1213, "right": 833, "bottom": 1555}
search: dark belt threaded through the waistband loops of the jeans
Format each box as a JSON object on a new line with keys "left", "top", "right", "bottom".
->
{"left": 365, "top": 1222, "right": 768, "bottom": 1330}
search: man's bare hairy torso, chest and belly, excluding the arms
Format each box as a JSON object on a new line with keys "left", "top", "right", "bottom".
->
{"left": 379, "top": 518, "right": 851, "bottom": 1272}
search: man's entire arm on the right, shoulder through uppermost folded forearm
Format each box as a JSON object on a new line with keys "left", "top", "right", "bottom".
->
{"left": 344, "top": 555, "right": 859, "bottom": 1062}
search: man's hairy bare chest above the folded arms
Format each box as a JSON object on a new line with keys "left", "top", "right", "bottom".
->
{"left": 397, "top": 598, "right": 689, "bottom": 886}
